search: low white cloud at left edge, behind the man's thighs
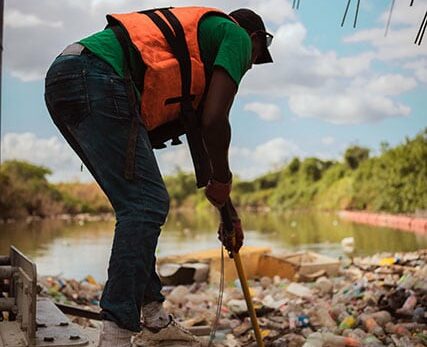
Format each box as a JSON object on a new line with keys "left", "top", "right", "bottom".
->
{"left": 1, "top": 133, "right": 93, "bottom": 182}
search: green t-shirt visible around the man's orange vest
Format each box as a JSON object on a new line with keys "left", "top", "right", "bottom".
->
{"left": 80, "top": 15, "right": 252, "bottom": 85}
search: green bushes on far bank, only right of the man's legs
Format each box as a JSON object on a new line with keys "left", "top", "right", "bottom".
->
{"left": 167, "top": 129, "right": 427, "bottom": 213}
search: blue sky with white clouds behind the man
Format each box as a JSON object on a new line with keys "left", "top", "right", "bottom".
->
{"left": 1, "top": 0, "right": 427, "bottom": 182}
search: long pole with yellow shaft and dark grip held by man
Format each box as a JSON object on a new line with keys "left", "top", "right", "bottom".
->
{"left": 220, "top": 199, "right": 264, "bottom": 347}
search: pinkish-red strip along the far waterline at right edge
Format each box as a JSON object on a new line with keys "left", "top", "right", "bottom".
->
{"left": 338, "top": 211, "right": 427, "bottom": 235}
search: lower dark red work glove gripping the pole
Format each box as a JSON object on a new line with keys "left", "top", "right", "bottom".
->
{"left": 218, "top": 200, "right": 244, "bottom": 258}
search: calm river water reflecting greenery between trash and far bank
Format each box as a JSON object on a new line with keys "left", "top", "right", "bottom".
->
{"left": 0, "top": 212, "right": 427, "bottom": 281}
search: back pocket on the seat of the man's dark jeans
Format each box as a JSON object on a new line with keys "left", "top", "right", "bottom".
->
{"left": 45, "top": 71, "right": 90, "bottom": 126}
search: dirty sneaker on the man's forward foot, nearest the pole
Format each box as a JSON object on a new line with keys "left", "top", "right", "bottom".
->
{"left": 132, "top": 316, "right": 202, "bottom": 347}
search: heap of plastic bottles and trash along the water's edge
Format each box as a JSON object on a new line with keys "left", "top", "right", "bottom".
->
{"left": 41, "top": 250, "right": 427, "bottom": 347}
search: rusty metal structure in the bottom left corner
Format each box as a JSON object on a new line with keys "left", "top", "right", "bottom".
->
{"left": 0, "top": 246, "right": 95, "bottom": 347}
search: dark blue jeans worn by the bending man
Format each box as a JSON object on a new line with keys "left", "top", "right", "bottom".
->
{"left": 45, "top": 53, "right": 169, "bottom": 331}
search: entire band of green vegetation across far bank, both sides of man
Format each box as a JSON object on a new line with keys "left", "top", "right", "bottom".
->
{"left": 0, "top": 129, "right": 427, "bottom": 219}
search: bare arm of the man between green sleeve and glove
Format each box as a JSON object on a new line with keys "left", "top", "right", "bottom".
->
{"left": 202, "top": 67, "right": 237, "bottom": 183}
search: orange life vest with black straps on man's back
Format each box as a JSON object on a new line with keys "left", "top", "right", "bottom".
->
{"left": 107, "top": 7, "right": 229, "bottom": 130}
